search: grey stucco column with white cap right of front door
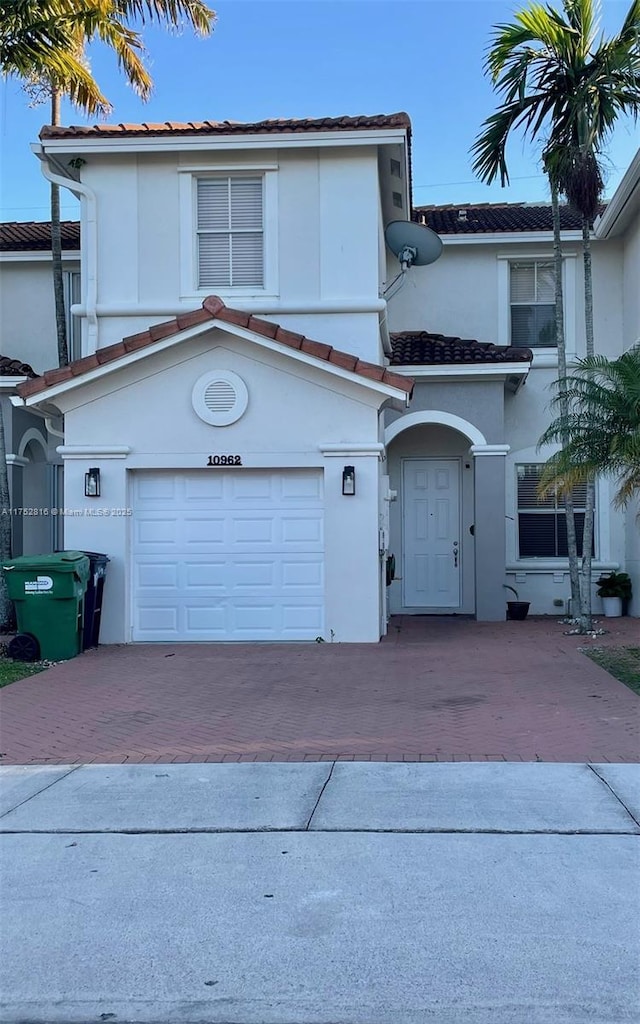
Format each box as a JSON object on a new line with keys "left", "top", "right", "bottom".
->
{"left": 471, "top": 444, "right": 509, "bottom": 623}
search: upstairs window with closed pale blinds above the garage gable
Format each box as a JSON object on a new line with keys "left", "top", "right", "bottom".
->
{"left": 197, "top": 176, "right": 264, "bottom": 289}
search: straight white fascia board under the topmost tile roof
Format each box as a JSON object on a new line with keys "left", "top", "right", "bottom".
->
{"left": 41, "top": 128, "right": 407, "bottom": 157}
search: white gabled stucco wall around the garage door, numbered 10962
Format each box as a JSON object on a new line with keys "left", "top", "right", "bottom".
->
{"left": 52, "top": 331, "right": 381, "bottom": 643}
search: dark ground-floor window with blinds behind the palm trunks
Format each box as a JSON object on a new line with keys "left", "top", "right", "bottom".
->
{"left": 516, "top": 463, "right": 594, "bottom": 558}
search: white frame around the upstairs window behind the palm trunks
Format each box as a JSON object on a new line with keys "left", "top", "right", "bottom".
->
{"left": 498, "top": 251, "right": 577, "bottom": 366}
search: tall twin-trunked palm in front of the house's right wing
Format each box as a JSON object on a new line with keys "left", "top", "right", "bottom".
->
{"left": 472, "top": 0, "right": 640, "bottom": 631}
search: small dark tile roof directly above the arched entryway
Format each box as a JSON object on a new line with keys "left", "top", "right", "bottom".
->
{"left": 391, "top": 331, "right": 534, "bottom": 367}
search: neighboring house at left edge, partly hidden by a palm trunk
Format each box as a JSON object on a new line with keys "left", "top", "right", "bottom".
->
{"left": 0, "top": 221, "right": 80, "bottom": 555}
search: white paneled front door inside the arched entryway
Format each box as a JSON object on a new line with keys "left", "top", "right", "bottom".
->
{"left": 402, "top": 459, "right": 462, "bottom": 608}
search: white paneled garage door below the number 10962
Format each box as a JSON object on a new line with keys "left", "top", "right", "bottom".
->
{"left": 132, "top": 469, "right": 325, "bottom": 641}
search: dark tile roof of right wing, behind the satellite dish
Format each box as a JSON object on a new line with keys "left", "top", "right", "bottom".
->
{"left": 414, "top": 203, "right": 605, "bottom": 234}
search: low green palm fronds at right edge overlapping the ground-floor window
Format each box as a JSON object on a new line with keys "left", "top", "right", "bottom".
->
{"left": 539, "top": 344, "right": 640, "bottom": 508}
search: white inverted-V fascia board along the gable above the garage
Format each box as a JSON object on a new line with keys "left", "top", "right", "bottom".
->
{"left": 22, "top": 318, "right": 411, "bottom": 407}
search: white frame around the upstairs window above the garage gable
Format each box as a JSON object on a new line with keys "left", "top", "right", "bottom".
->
{"left": 179, "top": 163, "right": 278, "bottom": 300}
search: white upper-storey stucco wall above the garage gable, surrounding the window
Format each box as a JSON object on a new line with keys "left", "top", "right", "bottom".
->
{"left": 74, "top": 145, "right": 380, "bottom": 360}
